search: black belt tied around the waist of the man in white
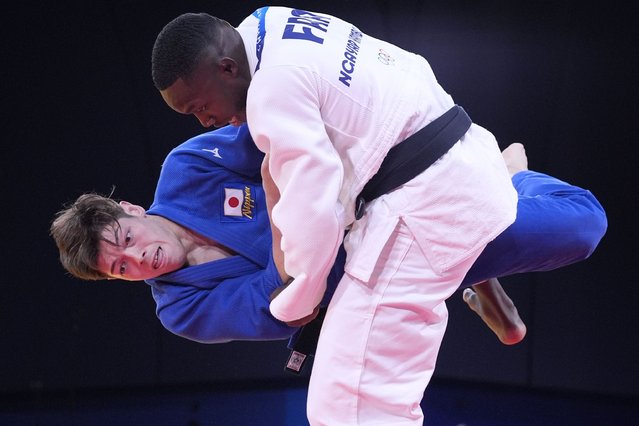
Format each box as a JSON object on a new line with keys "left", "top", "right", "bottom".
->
{"left": 355, "top": 105, "right": 472, "bottom": 219}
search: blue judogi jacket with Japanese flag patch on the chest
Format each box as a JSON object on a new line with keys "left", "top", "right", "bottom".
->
{"left": 147, "top": 126, "right": 341, "bottom": 343}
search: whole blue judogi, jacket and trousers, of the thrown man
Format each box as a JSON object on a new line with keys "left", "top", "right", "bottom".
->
{"left": 147, "top": 126, "right": 607, "bottom": 343}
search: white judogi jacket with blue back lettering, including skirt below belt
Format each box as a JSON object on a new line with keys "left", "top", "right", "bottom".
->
{"left": 237, "top": 7, "right": 516, "bottom": 320}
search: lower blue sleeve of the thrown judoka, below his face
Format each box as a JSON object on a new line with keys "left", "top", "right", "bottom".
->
{"left": 151, "top": 259, "right": 297, "bottom": 343}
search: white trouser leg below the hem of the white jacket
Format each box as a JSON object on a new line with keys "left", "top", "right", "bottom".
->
{"left": 308, "top": 221, "right": 479, "bottom": 426}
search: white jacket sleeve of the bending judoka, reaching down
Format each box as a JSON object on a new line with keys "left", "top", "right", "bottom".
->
{"left": 247, "top": 67, "right": 343, "bottom": 321}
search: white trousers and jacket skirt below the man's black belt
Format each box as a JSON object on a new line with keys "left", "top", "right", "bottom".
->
{"left": 307, "top": 131, "right": 516, "bottom": 426}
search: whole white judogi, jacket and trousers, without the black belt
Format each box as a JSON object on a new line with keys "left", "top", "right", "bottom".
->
{"left": 238, "top": 7, "right": 517, "bottom": 426}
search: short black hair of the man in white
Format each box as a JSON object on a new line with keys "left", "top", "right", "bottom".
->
{"left": 151, "top": 13, "right": 226, "bottom": 90}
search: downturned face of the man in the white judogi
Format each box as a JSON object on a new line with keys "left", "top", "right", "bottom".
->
{"left": 160, "top": 53, "right": 249, "bottom": 127}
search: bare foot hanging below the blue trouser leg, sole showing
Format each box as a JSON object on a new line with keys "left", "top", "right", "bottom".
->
{"left": 463, "top": 278, "right": 526, "bottom": 345}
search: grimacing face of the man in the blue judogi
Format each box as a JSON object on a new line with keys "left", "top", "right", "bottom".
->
{"left": 98, "top": 206, "right": 186, "bottom": 281}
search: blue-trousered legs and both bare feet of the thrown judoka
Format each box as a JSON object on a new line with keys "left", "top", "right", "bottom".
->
{"left": 463, "top": 143, "right": 606, "bottom": 345}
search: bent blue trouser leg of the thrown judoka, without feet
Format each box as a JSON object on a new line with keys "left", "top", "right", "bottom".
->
{"left": 461, "top": 171, "right": 608, "bottom": 288}
